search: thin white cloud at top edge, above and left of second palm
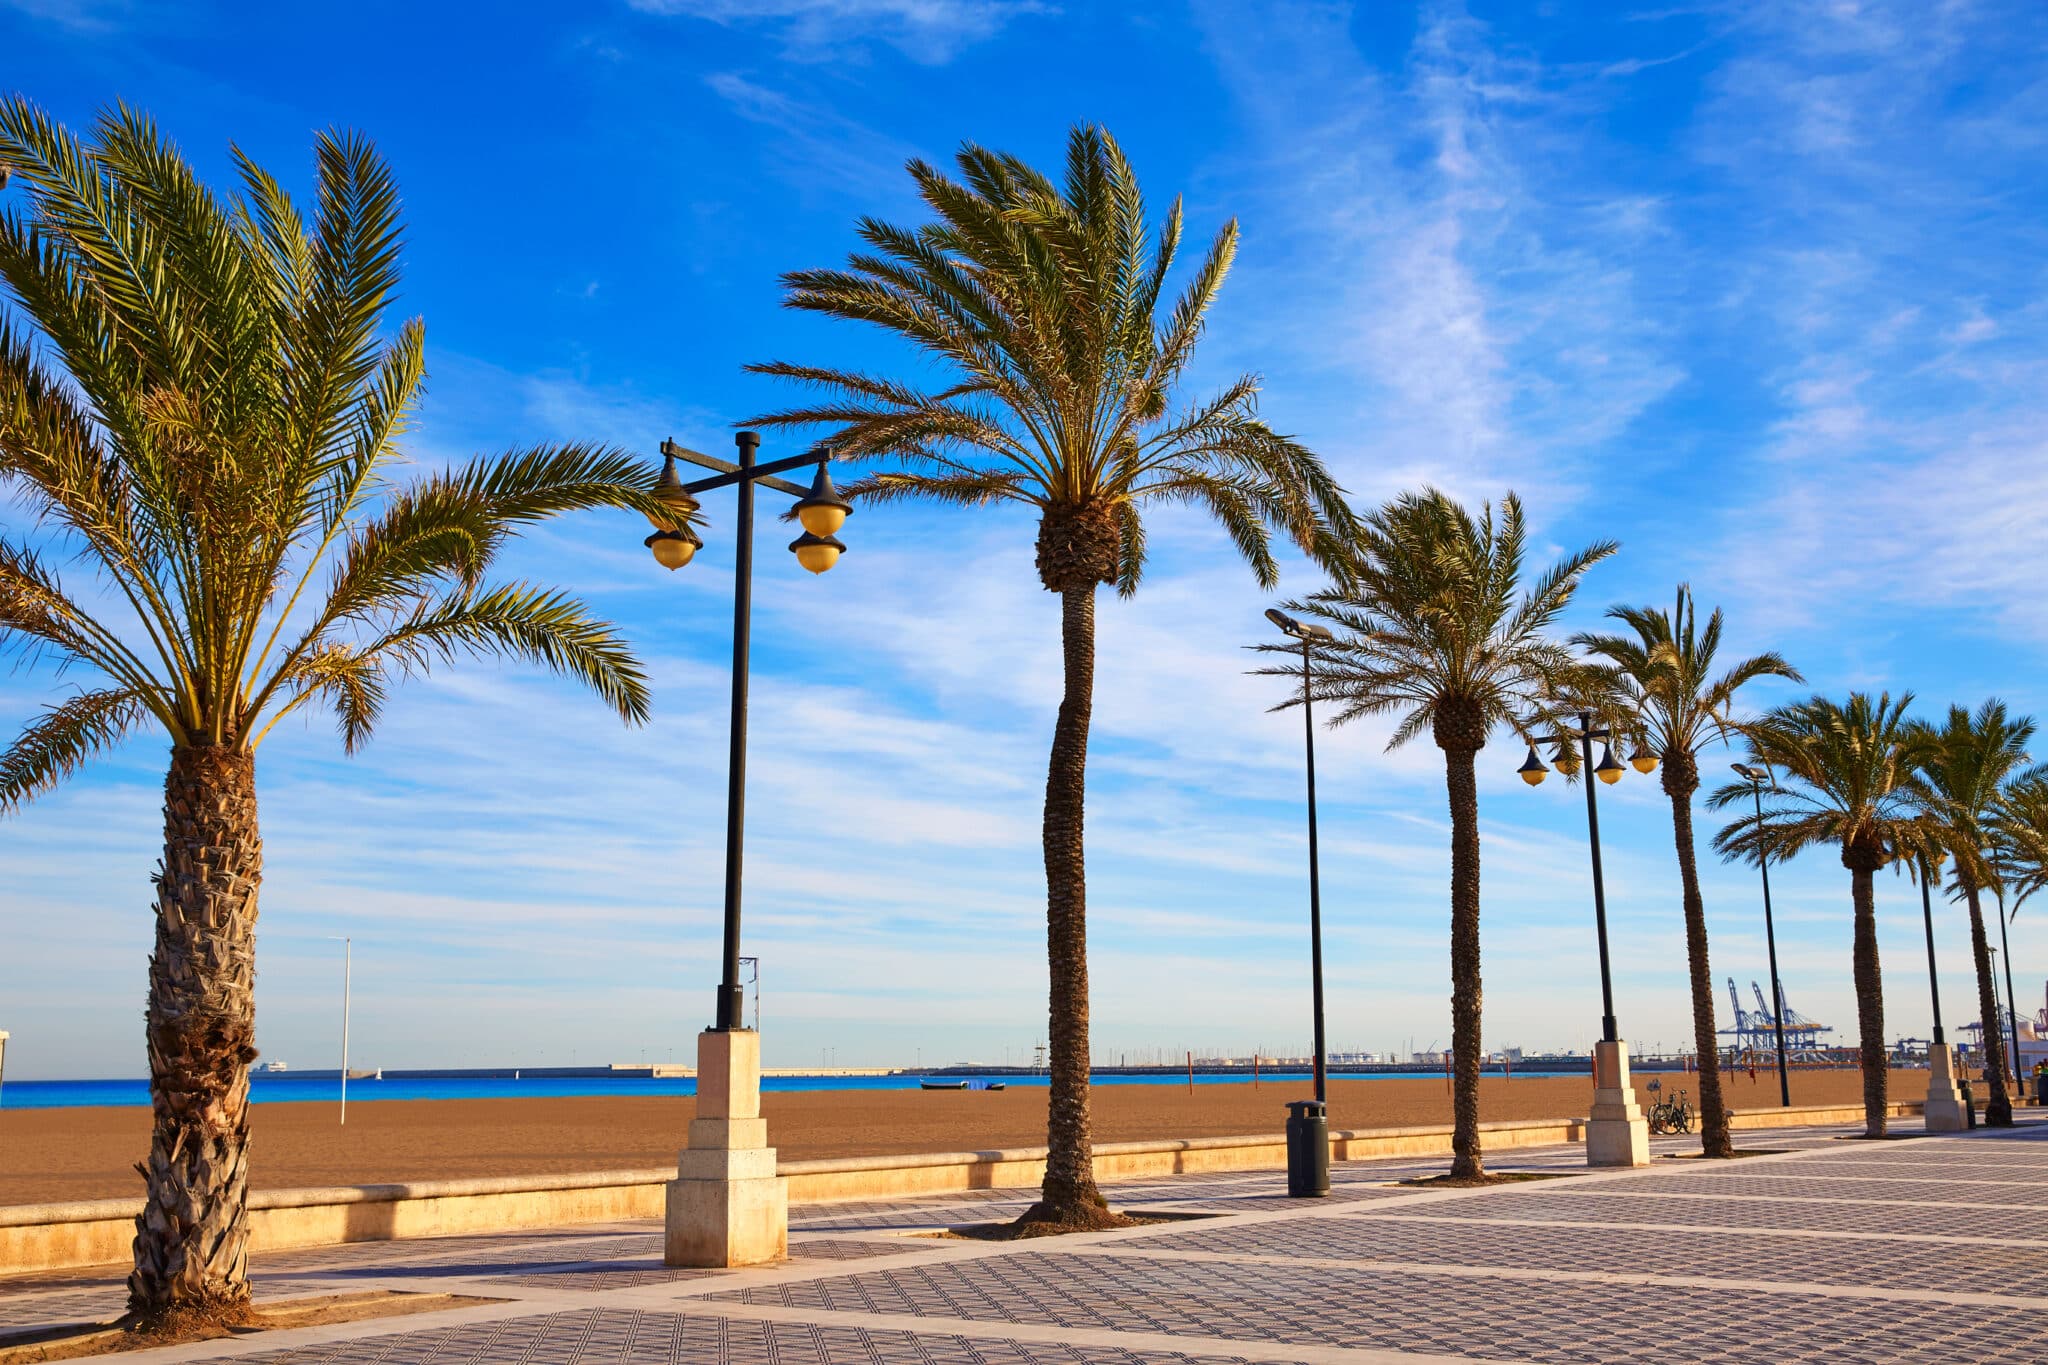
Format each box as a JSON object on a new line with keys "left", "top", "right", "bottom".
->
{"left": 629, "top": 0, "right": 1053, "bottom": 65}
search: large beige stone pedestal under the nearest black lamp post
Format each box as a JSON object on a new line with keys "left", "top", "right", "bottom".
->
{"left": 662, "top": 1029, "right": 788, "bottom": 1267}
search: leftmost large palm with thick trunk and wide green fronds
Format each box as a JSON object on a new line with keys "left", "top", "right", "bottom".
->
{"left": 0, "top": 100, "right": 679, "bottom": 1322}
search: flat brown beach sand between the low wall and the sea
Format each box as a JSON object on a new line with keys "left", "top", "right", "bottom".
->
{"left": 0, "top": 1070, "right": 1900, "bottom": 1203}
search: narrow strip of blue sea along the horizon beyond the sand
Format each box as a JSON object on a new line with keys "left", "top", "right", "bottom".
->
{"left": 0, "top": 1068, "right": 1565, "bottom": 1109}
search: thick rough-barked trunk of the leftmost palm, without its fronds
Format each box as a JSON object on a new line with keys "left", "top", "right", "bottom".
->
{"left": 129, "top": 745, "right": 262, "bottom": 1322}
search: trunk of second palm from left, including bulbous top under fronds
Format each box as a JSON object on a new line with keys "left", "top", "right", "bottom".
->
{"left": 1022, "top": 505, "right": 1122, "bottom": 1228}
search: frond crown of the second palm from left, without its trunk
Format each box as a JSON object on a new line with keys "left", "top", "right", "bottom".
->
{"left": 748, "top": 125, "right": 1354, "bottom": 591}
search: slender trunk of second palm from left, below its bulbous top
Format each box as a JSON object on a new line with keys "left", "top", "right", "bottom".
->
{"left": 1020, "top": 581, "right": 1110, "bottom": 1226}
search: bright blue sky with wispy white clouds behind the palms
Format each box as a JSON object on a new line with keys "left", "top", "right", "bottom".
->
{"left": 0, "top": 0, "right": 2048, "bottom": 1076}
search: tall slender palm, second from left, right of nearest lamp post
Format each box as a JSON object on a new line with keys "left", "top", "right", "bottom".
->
{"left": 752, "top": 127, "right": 1350, "bottom": 1228}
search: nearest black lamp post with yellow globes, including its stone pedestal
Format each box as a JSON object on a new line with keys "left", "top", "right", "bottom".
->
{"left": 645, "top": 432, "right": 852, "bottom": 1267}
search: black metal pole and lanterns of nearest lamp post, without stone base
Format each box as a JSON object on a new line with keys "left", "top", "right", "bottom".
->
{"left": 645, "top": 432, "right": 852, "bottom": 1031}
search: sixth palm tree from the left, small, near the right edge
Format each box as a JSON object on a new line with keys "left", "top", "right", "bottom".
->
{"left": 1921, "top": 698, "right": 2040, "bottom": 1128}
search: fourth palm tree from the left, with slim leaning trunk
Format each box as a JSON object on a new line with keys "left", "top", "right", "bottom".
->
{"left": 1573, "top": 583, "right": 1800, "bottom": 1156}
